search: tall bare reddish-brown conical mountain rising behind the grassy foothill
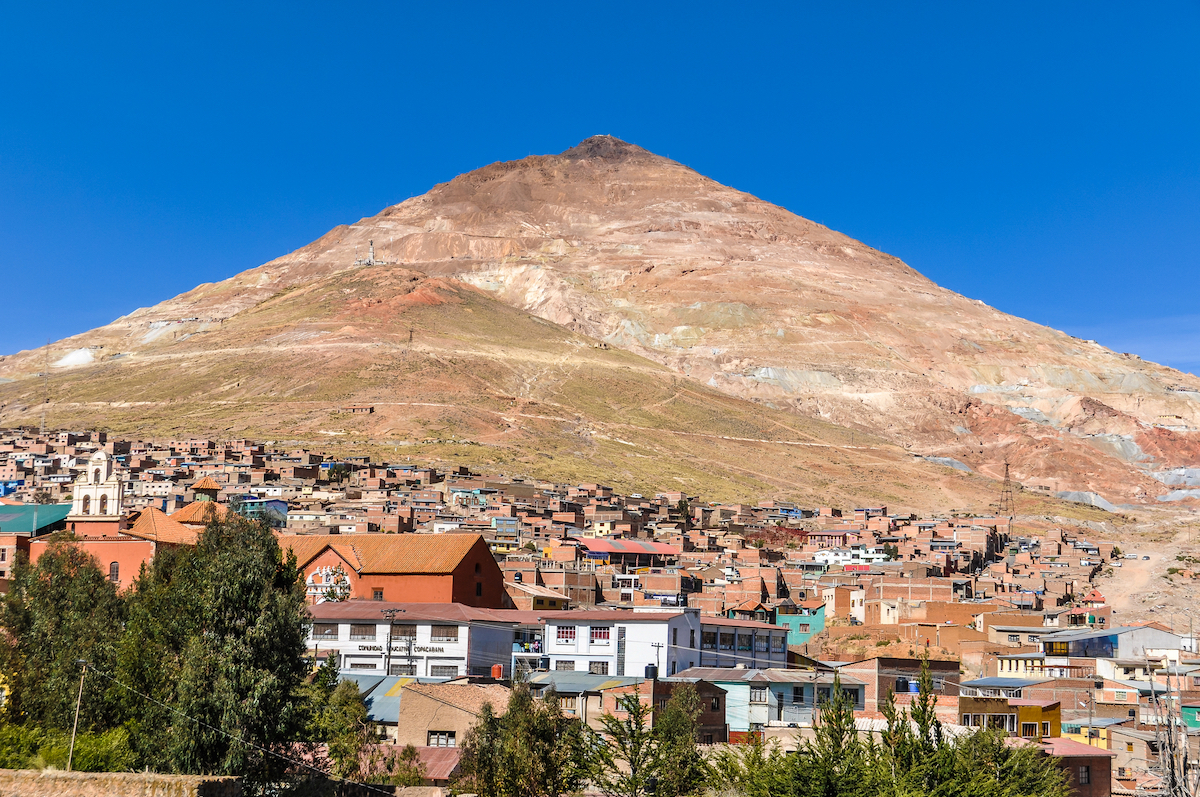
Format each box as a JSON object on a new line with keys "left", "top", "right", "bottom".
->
{"left": 0, "top": 137, "right": 1200, "bottom": 511}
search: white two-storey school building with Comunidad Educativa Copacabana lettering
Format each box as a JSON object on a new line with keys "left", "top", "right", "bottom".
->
{"left": 308, "top": 600, "right": 516, "bottom": 678}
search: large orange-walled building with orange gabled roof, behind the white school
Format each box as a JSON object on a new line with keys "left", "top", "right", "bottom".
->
{"left": 278, "top": 534, "right": 512, "bottom": 609}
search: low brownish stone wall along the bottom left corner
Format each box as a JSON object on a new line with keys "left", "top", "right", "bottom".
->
{"left": 0, "top": 769, "right": 241, "bottom": 797}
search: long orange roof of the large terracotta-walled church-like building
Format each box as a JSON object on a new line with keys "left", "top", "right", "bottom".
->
{"left": 278, "top": 535, "right": 484, "bottom": 574}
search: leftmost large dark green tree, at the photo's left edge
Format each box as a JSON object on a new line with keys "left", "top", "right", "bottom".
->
{"left": 0, "top": 535, "right": 124, "bottom": 729}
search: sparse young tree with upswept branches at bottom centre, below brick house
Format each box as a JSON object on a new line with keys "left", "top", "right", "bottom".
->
{"left": 592, "top": 688, "right": 661, "bottom": 797}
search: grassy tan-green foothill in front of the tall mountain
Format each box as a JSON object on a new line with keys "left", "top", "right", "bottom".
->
{"left": 0, "top": 265, "right": 1022, "bottom": 509}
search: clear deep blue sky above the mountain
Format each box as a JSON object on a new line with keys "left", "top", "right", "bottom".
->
{"left": 0, "top": 1, "right": 1200, "bottom": 372}
